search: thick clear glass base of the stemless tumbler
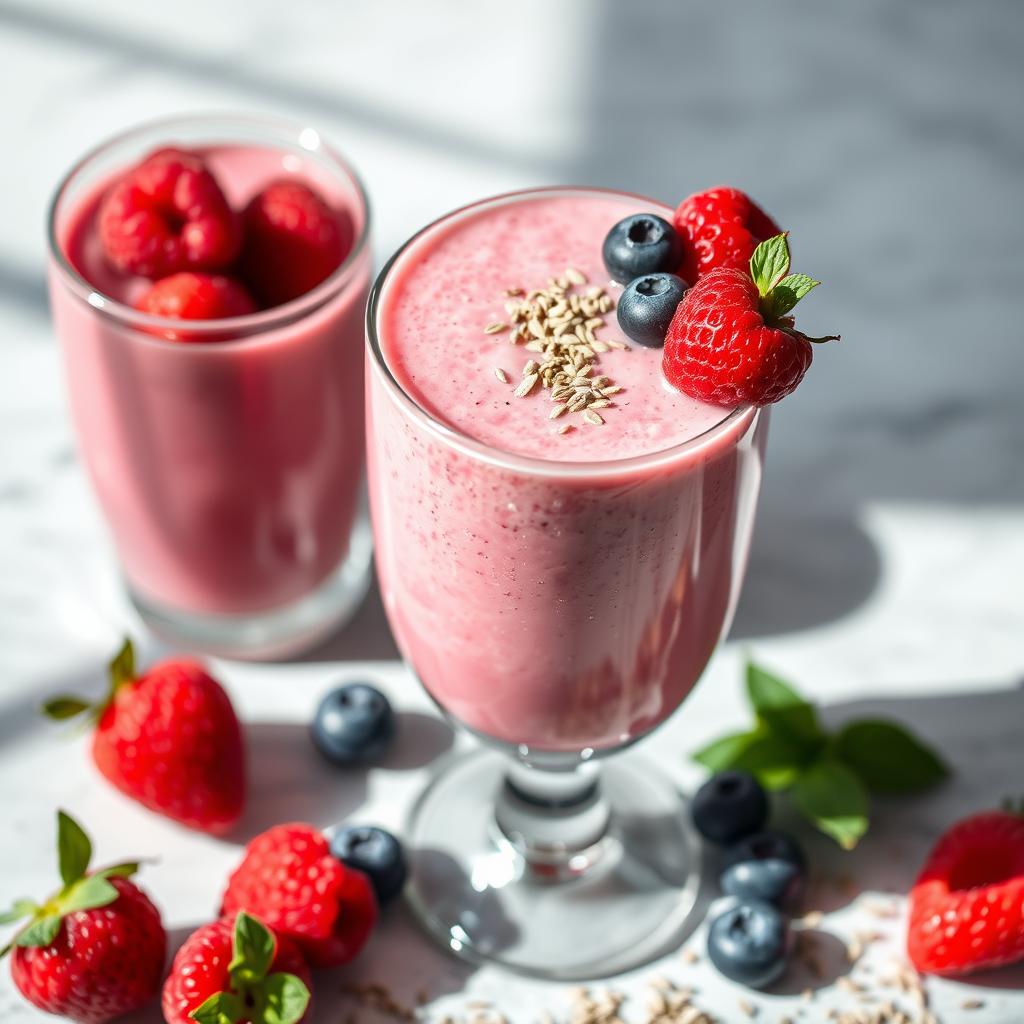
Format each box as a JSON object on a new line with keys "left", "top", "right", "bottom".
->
{"left": 128, "top": 512, "right": 373, "bottom": 660}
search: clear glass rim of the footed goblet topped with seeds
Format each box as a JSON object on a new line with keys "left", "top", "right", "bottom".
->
{"left": 367, "top": 185, "right": 759, "bottom": 478}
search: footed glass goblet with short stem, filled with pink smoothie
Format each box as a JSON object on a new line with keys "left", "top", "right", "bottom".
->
{"left": 367, "top": 189, "right": 768, "bottom": 979}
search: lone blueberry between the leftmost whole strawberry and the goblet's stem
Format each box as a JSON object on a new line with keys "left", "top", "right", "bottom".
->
{"left": 312, "top": 683, "right": 394, "bottom": 765}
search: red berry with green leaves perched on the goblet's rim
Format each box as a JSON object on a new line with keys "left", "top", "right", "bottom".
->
{"left": 662, "top": 234, "right": 836, "bottom": 406}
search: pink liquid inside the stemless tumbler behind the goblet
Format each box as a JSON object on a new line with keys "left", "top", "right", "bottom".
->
{"left": 50, "top": 145, "right": 370, "bottom": 614}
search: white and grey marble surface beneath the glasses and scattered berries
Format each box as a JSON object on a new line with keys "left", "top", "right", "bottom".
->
{"left": 0, "top": 0, "right": 1024, "bottom": 1024}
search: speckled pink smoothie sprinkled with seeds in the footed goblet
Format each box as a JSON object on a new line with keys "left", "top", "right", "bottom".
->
{"left": 368, "top": 191, "right": 767, "bottom": 752}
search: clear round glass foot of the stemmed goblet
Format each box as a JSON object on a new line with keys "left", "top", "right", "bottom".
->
{"left": 407, "top": 751, "right": 700, "bottom": 981}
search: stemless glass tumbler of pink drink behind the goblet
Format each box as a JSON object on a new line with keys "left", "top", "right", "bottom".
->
{"left": 49, "top": 116, "right": 372, "bottom": 656}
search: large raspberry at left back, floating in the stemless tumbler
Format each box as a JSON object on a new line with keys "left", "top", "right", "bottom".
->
{"left": 99, "top": 148, "right": 241, "bottom": 278}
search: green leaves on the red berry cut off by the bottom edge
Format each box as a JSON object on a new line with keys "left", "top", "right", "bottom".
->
{"left": 188, "top": 912, "right": 309, "bottom": 1024}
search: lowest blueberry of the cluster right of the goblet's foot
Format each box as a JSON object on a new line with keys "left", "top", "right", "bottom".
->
{"left": 708, "top": 900, "right": 793, "bottom": 988}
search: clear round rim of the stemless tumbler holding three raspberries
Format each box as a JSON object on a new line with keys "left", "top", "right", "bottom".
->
{"left": 46, "top": 112, "right": 372, "bottom": 351}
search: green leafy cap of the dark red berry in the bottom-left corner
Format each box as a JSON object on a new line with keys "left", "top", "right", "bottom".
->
{"left": 0, "top": 811, "right": 138, "bottom": 958}
